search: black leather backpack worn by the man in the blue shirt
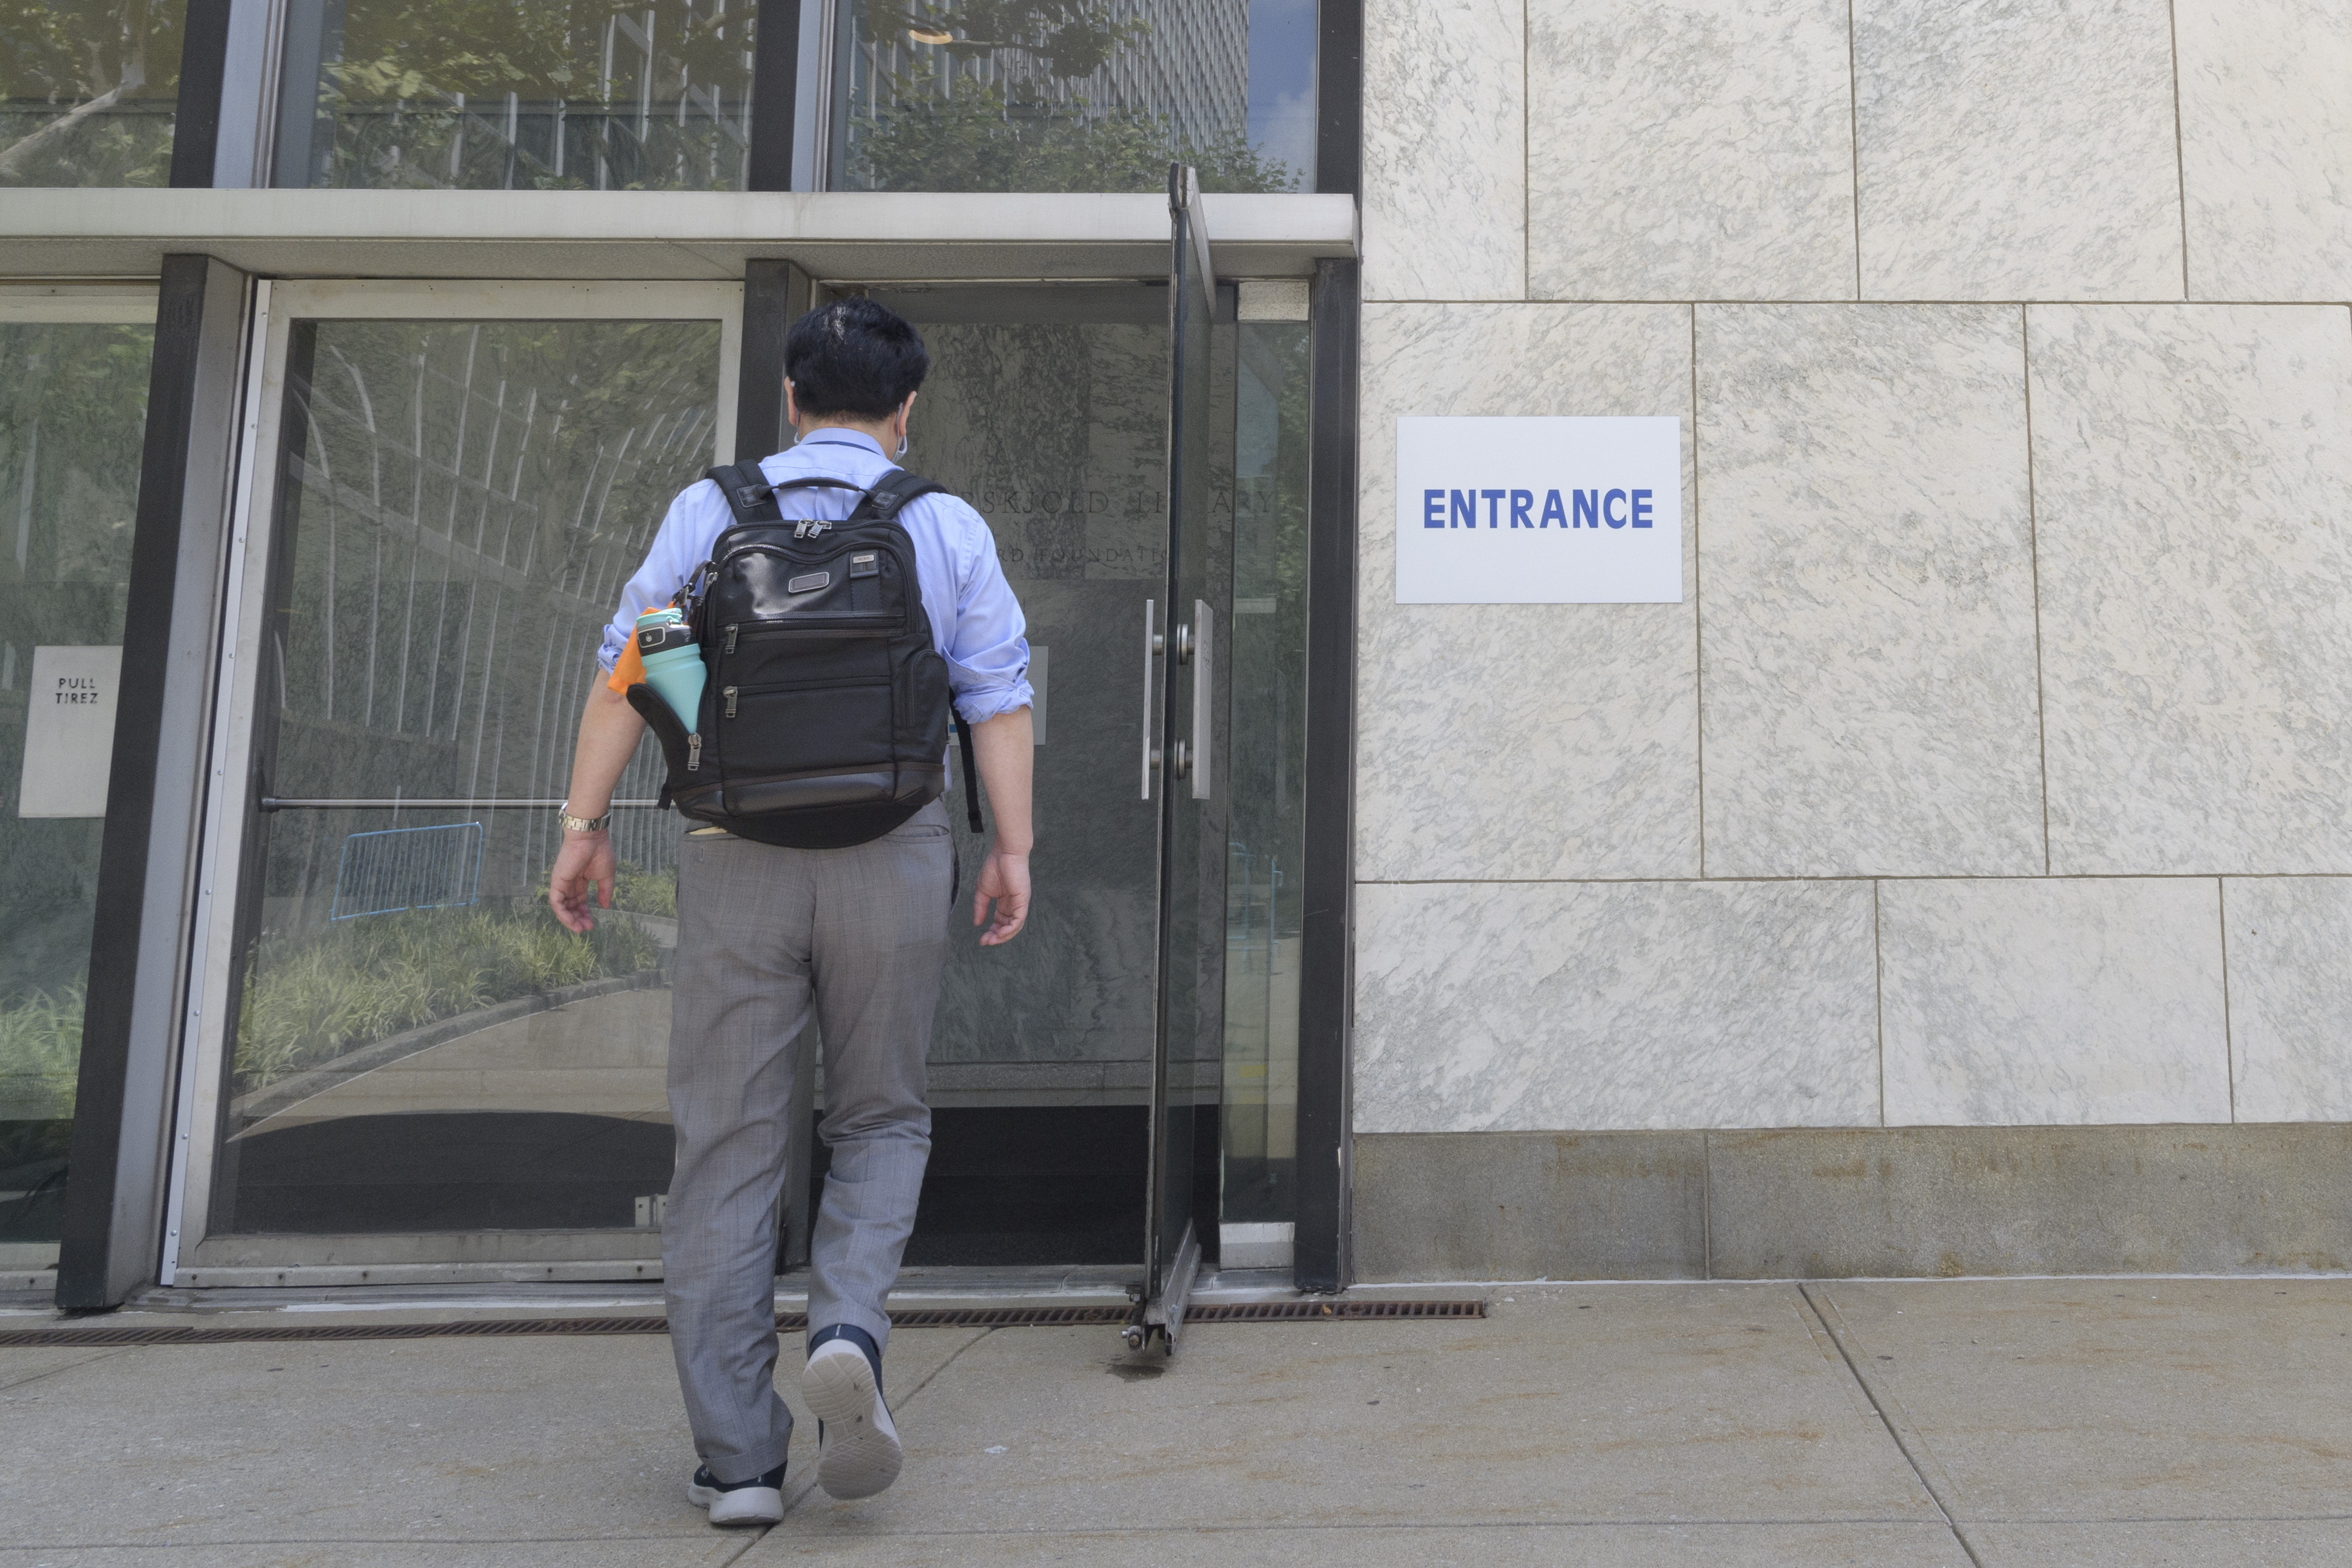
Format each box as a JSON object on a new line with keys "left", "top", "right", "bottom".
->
{"left": 628, "top": 463, "right": 981, "bottom": 849}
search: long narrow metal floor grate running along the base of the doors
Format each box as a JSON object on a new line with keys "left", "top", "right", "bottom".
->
{"left": 0, "top": 1300, "right": 1486, "bottom": 1352}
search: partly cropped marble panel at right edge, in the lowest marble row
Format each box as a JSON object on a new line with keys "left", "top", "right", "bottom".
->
{"left": 2220, "top": 877, "right": 2352, "bottom": 1121}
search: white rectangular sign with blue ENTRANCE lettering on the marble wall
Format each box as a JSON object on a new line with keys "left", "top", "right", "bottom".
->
{"left": 1397, "top": 414, "right": 1682, "bottom": 604}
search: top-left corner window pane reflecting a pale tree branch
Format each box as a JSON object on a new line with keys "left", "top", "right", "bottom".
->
{"left": 0, "top": 0, "right": 186, "bottom": 186}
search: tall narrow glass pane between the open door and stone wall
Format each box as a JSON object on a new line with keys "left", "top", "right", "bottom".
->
{"left": 1218, "top": 322, "right": 1310, "bottom": 1267}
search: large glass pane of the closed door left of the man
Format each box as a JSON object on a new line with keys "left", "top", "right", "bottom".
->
{"left": 212, "top": 320, "right": 720, "bottom": 1241}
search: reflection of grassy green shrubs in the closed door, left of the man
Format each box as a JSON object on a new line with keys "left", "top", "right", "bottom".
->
{"left": 235, "top": 908, "right": 658, "bottom": 1088}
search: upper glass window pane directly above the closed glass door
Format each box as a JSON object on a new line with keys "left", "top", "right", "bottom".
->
{"left": 274, "top": 0, "right": 755, "bottom": 190}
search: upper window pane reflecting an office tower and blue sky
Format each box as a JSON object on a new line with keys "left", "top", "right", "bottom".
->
{"left": 830, "top": 0, "right": 1315, "bottom": 190}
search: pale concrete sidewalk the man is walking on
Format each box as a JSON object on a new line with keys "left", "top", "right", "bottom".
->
{"left": 0, "top": 1279, "right": 2352, "bottom": 1568}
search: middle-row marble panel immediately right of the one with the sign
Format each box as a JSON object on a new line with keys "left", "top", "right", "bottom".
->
{"left": 1698, "top": 306, "right": 2046, "bottom": 877}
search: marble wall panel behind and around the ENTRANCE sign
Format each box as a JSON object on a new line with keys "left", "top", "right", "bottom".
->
{"left": 1357, "top": 306, "right": 1698, "bottom": 881}
